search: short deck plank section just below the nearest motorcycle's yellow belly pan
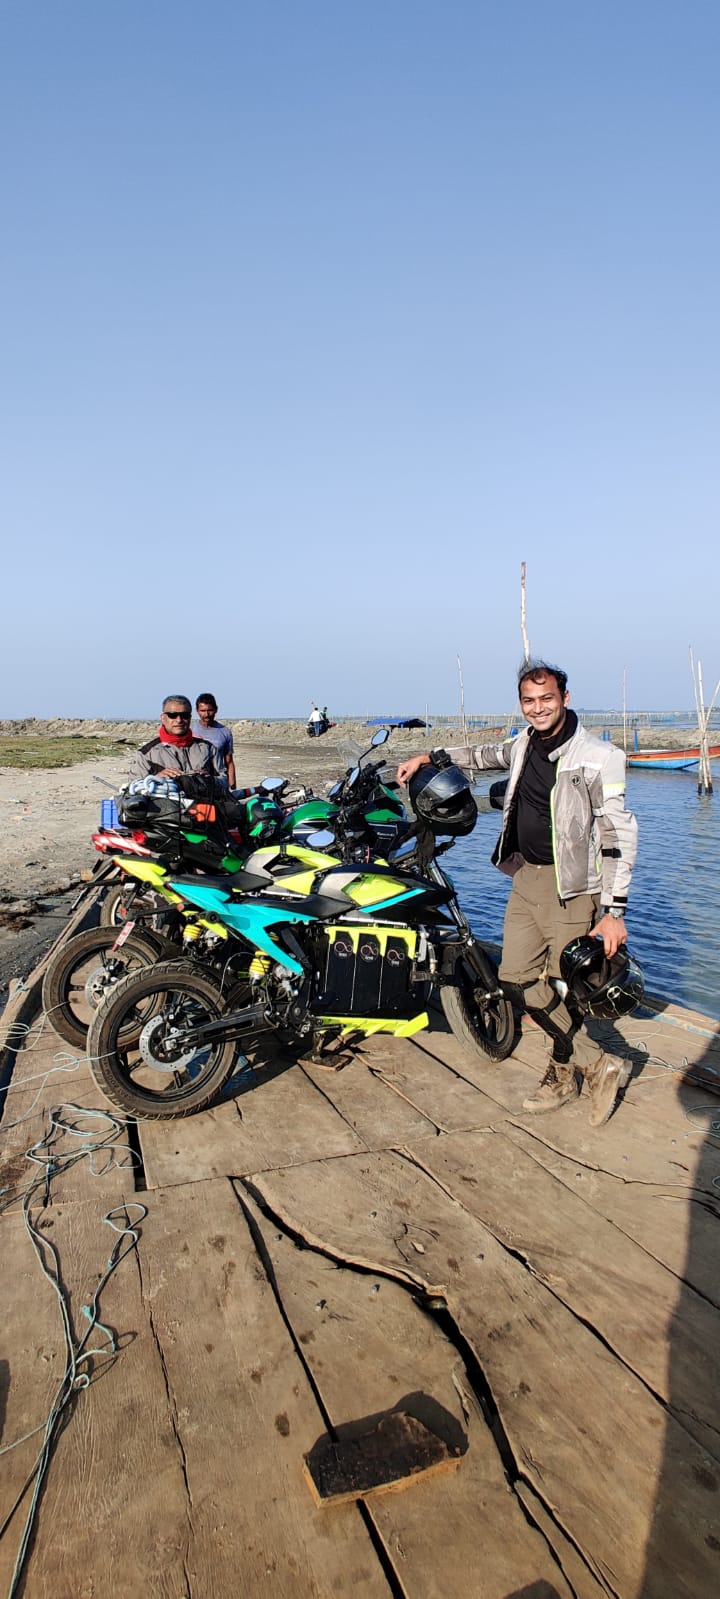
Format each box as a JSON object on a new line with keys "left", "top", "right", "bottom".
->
{"left": 296, "top": 1054, "right": 437, "bottom": 1150}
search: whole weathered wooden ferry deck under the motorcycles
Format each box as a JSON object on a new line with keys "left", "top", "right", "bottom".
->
{"left": 0, "top": 953, "right": 720, "bottom": 1599}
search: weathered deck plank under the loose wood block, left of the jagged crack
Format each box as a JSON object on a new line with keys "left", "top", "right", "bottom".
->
{"left": 246, "top": 1185, "right": 579, "bottom": 1599}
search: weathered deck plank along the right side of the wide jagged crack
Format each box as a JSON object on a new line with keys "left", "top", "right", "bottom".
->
{"left": 253, "top": 1153, "right": 718, "bottom": 1599}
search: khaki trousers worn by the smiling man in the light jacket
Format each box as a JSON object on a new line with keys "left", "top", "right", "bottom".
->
{"left": 499, "top": 863, "right": 603, "bottom": 1079}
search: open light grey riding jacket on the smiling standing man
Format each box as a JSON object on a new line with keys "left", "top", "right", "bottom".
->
{"left": 448, "top": 723, "right": 637, "bottom": 907}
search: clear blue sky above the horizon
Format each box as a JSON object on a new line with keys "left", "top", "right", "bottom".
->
{"left": 0, "top": 0, "right": 720, "bottom": 716}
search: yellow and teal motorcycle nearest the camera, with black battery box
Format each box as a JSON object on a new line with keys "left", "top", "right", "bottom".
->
{"left": 88, "top": 735, "right": 515, "bottom": 1118}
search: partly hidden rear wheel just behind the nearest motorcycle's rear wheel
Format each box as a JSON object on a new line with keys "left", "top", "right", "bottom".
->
{"left": 43, "top": 927, "right": 163, "bottom": 1049}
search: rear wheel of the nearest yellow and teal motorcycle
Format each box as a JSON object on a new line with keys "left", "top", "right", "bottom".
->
{"left": 88, "top": 961, "right": 238, "bottom": 1121}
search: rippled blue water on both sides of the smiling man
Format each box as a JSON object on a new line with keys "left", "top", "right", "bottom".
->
{"left": 442, "top": 771, "right": 720, "bottom": 1017}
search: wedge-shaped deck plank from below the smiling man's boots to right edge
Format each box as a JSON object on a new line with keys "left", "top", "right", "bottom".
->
{"left": 502, "top": 1121, "right": 720, "bottom": 1308}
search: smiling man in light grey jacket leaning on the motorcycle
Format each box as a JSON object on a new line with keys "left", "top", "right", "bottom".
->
{"left": 398, "top": 660, "right": 637, "bottom": 1127}
